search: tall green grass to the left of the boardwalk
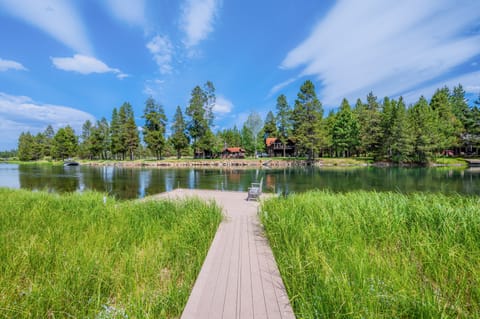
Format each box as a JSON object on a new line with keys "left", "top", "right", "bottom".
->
{"left": 0, "top": 189, "right": 221, "bottom": 318}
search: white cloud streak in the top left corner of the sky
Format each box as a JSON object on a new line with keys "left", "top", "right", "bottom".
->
{"left": 0, "top": 0, "right": 92, "bottom": 54}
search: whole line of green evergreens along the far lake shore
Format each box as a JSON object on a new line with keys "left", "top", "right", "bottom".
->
{"left": 18, "top": 80, "right": 480, "bottom": 163}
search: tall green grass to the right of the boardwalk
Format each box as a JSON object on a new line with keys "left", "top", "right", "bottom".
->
{"left": 261, "top": 192, "right": 480, "bottom": 318}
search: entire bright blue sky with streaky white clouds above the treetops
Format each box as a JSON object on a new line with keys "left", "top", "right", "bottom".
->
{"left": 0, "top": 0, "right": 480, "bottom": 150}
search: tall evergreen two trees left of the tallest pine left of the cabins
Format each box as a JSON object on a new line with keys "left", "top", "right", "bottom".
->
{"left": 142, "top": 97, "right": 167, "bottom": 160}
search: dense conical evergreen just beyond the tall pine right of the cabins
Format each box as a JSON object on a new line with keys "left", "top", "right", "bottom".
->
{"left": 332, "top": 99, "right": 358, "bottom": 157}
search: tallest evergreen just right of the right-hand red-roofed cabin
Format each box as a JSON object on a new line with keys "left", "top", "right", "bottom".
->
{"left": 293, "top": 80, "right": 325, "bottom": 160}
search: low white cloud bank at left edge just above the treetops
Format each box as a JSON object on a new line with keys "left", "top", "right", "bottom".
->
{"left": 0, "top": 92, "right": 95, "bottom": 149}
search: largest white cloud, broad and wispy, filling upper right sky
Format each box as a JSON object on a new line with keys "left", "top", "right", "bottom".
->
{"left": 281, "top": 0, "right": 480, "bottom": 104}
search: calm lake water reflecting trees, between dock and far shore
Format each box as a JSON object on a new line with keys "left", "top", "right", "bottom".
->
{"left": 0, "top": 164, "right": 480, "bottom": 199}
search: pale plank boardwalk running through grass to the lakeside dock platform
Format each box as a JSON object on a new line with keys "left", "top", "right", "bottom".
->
{"left": 158, "top": 189, "right": 295, "bottom": 319}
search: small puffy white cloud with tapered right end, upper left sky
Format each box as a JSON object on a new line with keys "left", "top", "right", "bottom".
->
{"left": 51, "top": 54, "right": 128, "bottom": 79}
